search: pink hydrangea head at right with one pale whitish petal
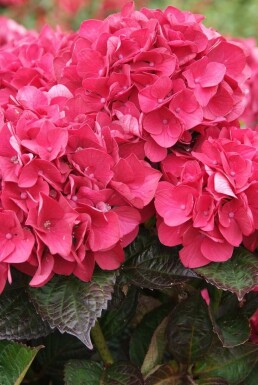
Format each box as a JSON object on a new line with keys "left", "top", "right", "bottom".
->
{"left": 155, "top": 127, "right": 258, "bottom": 268}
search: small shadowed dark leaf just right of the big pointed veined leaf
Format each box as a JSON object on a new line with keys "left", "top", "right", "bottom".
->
{"left": 99, "top": 286, "right": 138, "bottom": 340}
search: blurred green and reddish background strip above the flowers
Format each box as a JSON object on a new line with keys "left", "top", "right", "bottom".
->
{"left": 0, "top": 0, "right": 258, "bottom": 38}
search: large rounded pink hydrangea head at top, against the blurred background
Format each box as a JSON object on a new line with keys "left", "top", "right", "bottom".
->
{"left": 53, "top": 3, "right": 249, "bottom": 162}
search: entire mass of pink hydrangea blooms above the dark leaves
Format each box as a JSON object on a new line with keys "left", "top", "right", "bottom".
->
{"left": 0, "top": 3, "right": 255, "bottom": 290}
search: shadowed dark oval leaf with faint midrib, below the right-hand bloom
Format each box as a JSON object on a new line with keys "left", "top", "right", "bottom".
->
{"left": 168, "top": 295, "right": 213, "bottom": 364}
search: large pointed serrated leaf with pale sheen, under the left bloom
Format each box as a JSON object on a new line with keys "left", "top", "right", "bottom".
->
{"left": 29, "top": 272, "right": 115, "bottom": 349}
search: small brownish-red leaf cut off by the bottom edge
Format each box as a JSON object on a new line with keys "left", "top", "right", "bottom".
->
{"left": 145, "top": 365, "right": 184, "bottom": 385}
